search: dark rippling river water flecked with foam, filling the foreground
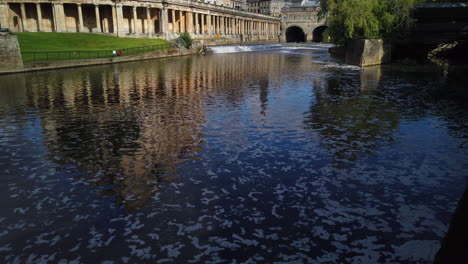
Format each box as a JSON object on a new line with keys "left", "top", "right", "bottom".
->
{"left": 0, "top": 46, "right": 468, "bottom": 263}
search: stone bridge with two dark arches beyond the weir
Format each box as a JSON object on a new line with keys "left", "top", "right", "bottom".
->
{"left": 281, "top": 0, "right": 328, "bottom": 42}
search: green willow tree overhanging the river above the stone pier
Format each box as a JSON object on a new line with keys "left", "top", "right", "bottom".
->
{"left": 320, "top": 0, "right": 418, "bottom": 44}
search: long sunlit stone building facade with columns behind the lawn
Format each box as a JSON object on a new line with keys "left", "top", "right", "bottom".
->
{"left": 0, "top": 0, "right": 280, "bottom": 41}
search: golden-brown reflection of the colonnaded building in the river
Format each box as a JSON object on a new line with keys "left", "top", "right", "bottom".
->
{"left": 27, "top": 54, "right": 279, "bottom": 208}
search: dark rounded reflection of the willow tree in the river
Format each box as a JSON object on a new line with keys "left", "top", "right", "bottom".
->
{"left": 304, "top": 69, "right": 400, "bottom": 164}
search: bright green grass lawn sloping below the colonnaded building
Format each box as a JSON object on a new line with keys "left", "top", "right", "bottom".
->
{"left": 15, "top": 32, "right": 173, "bottom": 62}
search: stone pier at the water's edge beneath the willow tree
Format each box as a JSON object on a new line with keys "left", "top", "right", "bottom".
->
{"left": 345, "top": 39, "right": 391, "bottom": 66}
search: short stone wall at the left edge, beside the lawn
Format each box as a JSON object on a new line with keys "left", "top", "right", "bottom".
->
{"left": 0, "top": 32, "right": 23, "bottom": 71}
